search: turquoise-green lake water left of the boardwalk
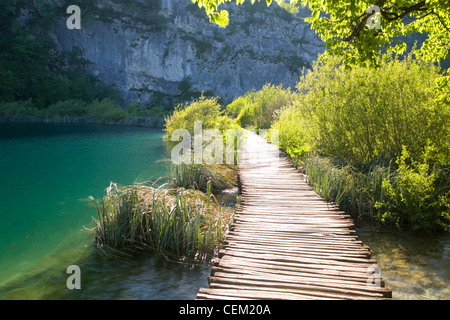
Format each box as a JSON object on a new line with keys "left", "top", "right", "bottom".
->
{"left": 0, "top": 123, "right": 209, "bottom": 299}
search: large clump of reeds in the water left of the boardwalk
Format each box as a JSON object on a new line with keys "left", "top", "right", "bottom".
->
{"left": 93, "top": 183, "right": 234, "bottom": 261}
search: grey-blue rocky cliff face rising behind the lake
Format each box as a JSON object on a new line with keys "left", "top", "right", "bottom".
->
{"left": 52, "top": 0, "right": 324, "bottom": 104}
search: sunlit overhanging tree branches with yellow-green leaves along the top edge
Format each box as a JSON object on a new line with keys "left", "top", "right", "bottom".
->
{"left": 191, "top": 0, "right": 450, "bottom": 64}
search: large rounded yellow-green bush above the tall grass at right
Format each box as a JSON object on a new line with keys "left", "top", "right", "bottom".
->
{"left": 296, "top": 53, "right": 450, "bottom": 163}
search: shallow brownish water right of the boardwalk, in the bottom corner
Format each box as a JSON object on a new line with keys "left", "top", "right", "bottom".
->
{"left": 357, "top": 228, "right": 450, "bottom": 300}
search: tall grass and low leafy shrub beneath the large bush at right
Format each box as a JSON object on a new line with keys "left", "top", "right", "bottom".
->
{"left": 304, "top": 153, "right": 450, "bottom": 232}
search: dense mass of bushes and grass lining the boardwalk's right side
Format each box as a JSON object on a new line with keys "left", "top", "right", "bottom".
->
{"left": 227, "top": 56, "right": 450, "bottom": 231}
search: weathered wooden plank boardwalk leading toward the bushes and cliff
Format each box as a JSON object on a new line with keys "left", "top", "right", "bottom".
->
{"left": 197, "top": 132, "right": 391, "bottom": 300}
